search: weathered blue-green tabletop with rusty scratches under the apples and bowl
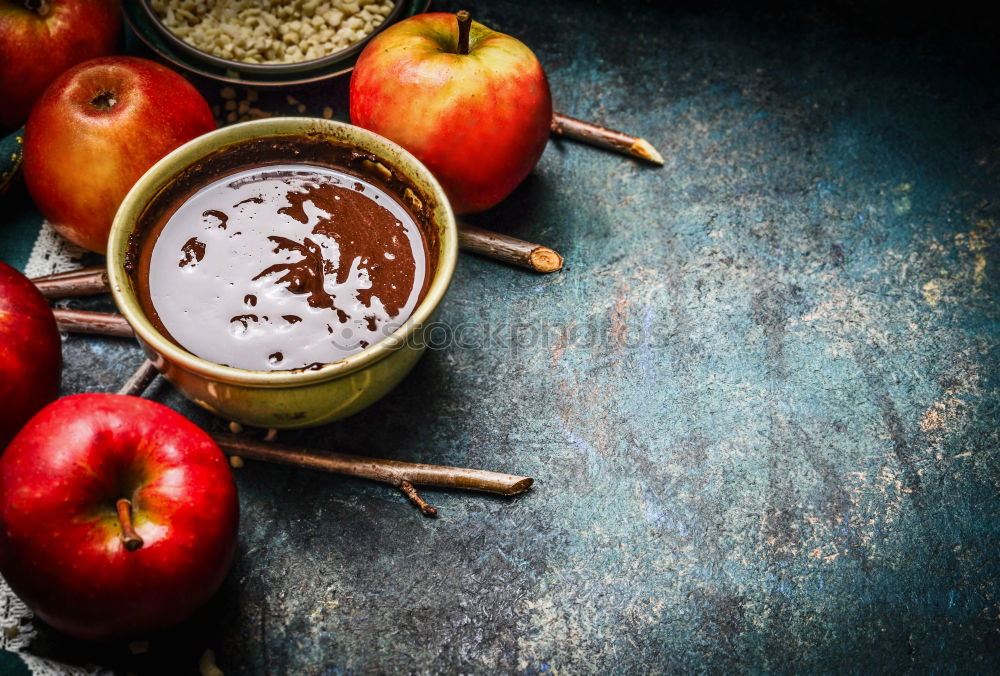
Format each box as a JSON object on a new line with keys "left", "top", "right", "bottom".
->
{"left": 9, "top": 0, "right": 1000, "bottom": 674}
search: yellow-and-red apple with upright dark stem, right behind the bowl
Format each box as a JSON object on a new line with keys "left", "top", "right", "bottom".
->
{"left": 350, "top": 12, "right": 552, "bottom": 213}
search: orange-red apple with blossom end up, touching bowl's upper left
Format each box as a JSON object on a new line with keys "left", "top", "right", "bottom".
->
{"left": 24, "top": 56, "right": 215, "bottom": 253}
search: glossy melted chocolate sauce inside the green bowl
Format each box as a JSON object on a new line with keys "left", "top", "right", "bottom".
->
{"left": 137, "top": 164, "right": 430, "bottom": 371}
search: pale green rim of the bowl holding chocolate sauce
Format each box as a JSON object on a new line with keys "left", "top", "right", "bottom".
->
{"left": 107, "top": 117, "right": 458, "bottom": 388}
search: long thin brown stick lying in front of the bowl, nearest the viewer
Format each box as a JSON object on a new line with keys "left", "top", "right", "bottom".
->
{"left": 212, "top": 434, "right": 534, "bottom": 495}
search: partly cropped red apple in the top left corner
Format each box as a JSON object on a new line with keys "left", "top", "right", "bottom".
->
{"left": 0, "top": 0, "right": 122, "bottom": 127}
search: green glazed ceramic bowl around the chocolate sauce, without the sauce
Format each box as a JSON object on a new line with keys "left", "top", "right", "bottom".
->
{"left": 108, "top": 117, "right": 458, "bottom": 428}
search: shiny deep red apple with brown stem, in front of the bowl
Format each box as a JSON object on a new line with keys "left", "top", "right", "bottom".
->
{"left": 0, "top": 394, "right": 239, "bottom": 639}
